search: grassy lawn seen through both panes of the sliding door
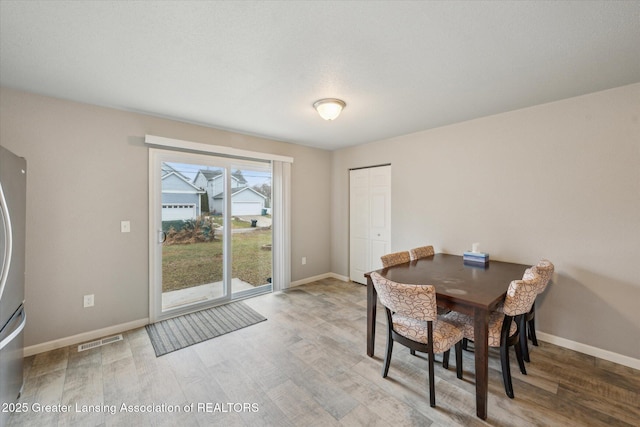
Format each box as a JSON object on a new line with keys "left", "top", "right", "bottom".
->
{"left": 162, "top": 230, "right": 271, "bottom": 292}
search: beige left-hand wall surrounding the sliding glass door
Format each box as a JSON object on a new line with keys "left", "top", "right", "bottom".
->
{"left": 0, "top": 88, "right": 331, "bottom": 346}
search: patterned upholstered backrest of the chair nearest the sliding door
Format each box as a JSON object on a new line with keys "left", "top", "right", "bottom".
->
{"left": 371, "top": 272, "right": 438, "bottom": 321}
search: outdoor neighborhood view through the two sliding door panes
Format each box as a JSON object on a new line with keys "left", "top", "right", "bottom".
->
{"left": 161, "top": 162, "right": 272, "bottom": 310}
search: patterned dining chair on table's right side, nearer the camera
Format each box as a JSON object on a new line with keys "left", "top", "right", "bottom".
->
{"left": 443, "top": 268, "right": 541, "bottom": 399}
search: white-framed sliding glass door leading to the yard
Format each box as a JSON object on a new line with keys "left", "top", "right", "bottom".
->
{"left": 150, "top": 150, "right": 273, "bottom": 321}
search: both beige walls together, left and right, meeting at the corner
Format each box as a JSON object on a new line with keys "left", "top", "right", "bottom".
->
{"left": 0, "top": 84, "right": 640, "bottom": 359}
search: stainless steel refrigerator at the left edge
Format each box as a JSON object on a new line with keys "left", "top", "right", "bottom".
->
{"left": 0, "top": 146, "right": 27, "bottom": 425}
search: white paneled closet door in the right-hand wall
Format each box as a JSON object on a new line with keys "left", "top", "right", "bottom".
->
{"left": 349, "top": 165, "right": 391, "bottom": 284}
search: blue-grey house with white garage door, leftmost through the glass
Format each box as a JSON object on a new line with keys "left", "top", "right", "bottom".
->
{"left": 162, "top": 163, "right": 204, "bottom": 221}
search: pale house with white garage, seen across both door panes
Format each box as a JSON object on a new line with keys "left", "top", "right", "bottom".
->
{"left": 193, "top": 169, "right": 267, "bottom": 216}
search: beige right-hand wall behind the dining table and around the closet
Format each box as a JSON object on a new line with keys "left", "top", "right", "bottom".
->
{"left": 332, "top": 84, "right": 640, "bottom": 359}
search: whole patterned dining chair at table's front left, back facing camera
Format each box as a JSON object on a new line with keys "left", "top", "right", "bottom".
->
{"left": 371, "top": 272, "right": 463, "bottom": 406}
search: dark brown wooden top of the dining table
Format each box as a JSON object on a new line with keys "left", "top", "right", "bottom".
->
{"left": 364, "top": 253, "right": 530, "bottom": 311}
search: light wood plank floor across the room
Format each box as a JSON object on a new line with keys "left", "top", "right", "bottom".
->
{"left": 9, "top": 279, "right": 640, "bottom": 427}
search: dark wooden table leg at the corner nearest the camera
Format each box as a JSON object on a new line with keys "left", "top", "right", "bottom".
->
{"left": 473, "top": 308, "right": 489, "bottom": 420}
